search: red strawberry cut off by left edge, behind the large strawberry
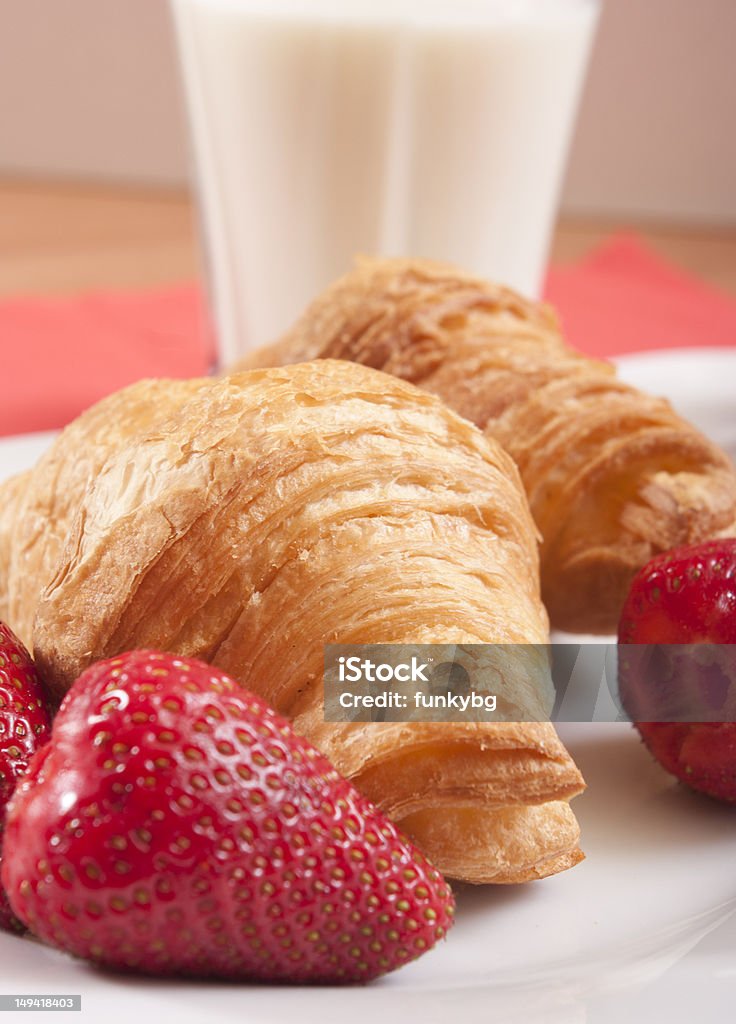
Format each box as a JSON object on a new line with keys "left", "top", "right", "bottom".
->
{"left": 0, "top": 623, "right": 50, "bottom": 931}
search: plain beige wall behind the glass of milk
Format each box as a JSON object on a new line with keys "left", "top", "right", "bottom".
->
{"left": 0, "top": 0, "right": 736, "bottom": 223}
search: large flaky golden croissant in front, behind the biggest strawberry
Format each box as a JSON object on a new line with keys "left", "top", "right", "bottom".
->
{"left": 5, "top": 360, "right": 583, "bottom": 883}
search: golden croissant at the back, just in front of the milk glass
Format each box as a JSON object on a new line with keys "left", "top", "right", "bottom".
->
{"left": 239, "top": 260, "right": 736, "bottom": 633}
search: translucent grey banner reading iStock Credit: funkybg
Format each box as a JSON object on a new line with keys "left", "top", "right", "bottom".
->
{"left": 323, "top": 643, "right": 736, "bottom": 722}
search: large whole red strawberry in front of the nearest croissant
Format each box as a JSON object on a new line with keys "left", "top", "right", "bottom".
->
{"left": 3, "top": 651, "right": 453, "bottom": 982}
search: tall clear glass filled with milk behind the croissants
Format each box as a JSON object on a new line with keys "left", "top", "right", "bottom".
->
{"left": 171, "top": 0, "right": 599, "bottom": 365}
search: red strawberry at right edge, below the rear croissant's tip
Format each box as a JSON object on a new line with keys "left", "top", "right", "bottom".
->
{"left": 618, "top": 540, "right": 736, "bottom": 803}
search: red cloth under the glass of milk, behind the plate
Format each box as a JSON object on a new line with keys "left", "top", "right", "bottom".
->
{"left": 0, "top": 236, "right": 736, "bottom": 434}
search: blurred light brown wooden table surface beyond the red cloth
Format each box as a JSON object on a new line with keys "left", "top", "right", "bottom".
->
{"left": 0, "top": 179, "right": 736, "bottom": 295}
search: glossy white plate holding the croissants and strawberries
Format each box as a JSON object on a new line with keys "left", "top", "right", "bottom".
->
{"left": 0, "top": 350, "right": 736, "bottom": 1024}
